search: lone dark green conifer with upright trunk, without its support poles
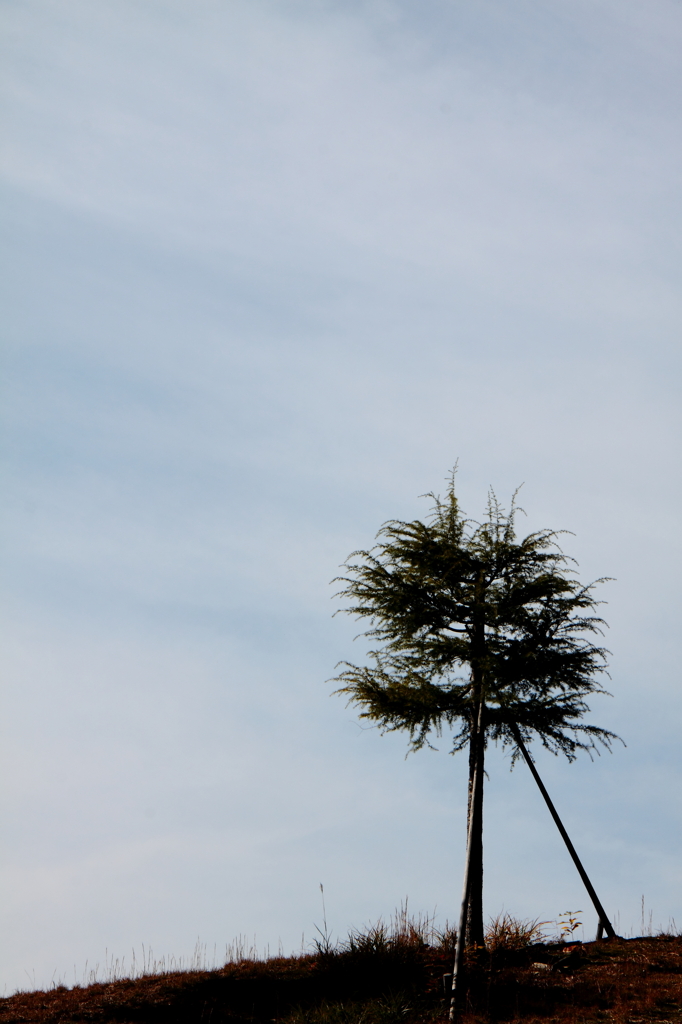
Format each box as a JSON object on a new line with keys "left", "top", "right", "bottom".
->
{"left": 335, "top": 473, "right": 616, "bottom": 945}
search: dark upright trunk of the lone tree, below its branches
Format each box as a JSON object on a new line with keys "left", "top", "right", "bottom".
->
{"left": 465, "top": 688, "right": 485, "bottom": 947}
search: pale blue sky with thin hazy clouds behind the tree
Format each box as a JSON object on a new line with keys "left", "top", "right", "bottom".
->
{"left": 0, "top": 0, "right": 682, "bottom": 994}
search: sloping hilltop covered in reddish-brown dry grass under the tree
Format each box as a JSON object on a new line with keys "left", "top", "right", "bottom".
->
{"left": 0, "top": 910, "right": 682, "bottom": 1024}
